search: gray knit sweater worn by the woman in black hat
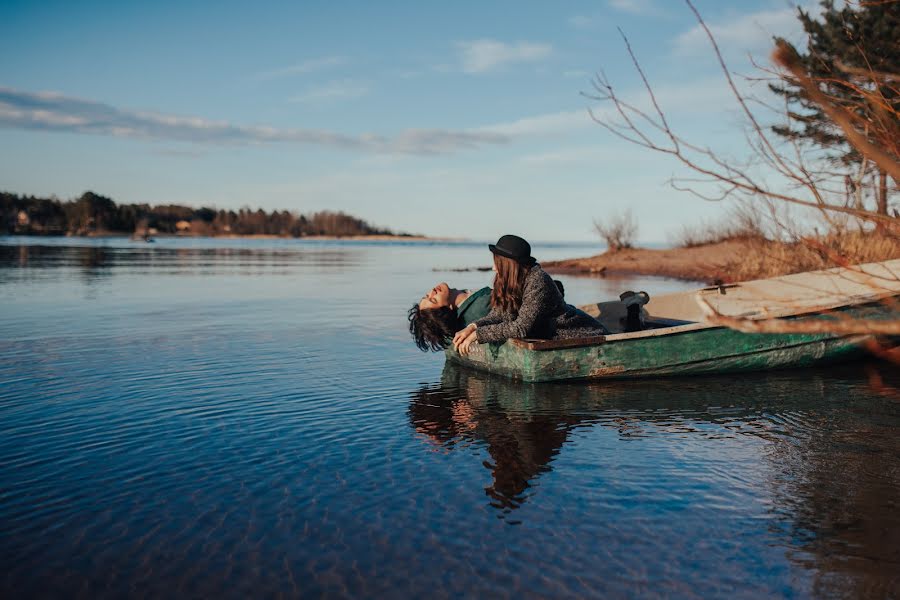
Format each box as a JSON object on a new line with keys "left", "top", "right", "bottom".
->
{"left": 475, "top": 265, "right": 607, "bottom": 343}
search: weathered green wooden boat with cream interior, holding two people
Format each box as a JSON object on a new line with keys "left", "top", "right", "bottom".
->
{"left": 446, "top": 260, "right": 900, "bottom": 382}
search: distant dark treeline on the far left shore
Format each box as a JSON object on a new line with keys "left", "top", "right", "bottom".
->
{"left": 0, "top": 192, "right": 407, "bottom": 237}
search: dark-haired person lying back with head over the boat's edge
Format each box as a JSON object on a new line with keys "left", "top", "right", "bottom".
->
{"left": 407, "top": 279, "right": 568, "bottom": 352}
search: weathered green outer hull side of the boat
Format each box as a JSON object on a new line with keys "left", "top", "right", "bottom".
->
{"left": 447, "top": 303, "right": 896, "bottom": 382}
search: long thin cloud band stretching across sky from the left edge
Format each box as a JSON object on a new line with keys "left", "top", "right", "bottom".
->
{"left": 0, "top": 72, "right": 756, "bottom": 156}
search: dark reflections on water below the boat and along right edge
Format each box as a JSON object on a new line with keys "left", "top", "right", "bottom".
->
{"left": 409, "top": 363, "right": 900, "bottom": 597}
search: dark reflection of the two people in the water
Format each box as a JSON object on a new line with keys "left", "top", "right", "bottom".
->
{"left": 409, "top": 363, "right": 582, "bottom": 513}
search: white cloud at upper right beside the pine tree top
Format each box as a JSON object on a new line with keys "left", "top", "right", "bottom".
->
{"left": 675, "top": 8, "right": 802, "bottom": 54}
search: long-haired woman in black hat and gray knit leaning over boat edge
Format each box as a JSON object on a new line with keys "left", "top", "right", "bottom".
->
{"left": 453, "top": 235, "right": 606, "bottom": 354}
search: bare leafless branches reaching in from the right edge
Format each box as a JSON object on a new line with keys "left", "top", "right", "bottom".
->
{"left": 589, "top": 0, "right": 900, "bottom": 362}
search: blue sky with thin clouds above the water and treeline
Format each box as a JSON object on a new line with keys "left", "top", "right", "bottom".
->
{"left": 0, "top": 0, "right": 816, "bottom": 242}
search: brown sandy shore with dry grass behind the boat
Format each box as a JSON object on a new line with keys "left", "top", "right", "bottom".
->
{"left": 541, "top": 240, "right": 748, "bottom": 283}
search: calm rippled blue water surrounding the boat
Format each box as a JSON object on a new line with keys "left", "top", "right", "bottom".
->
{"left": 0, "top": 238, "right": 900, "bottom": 598}
